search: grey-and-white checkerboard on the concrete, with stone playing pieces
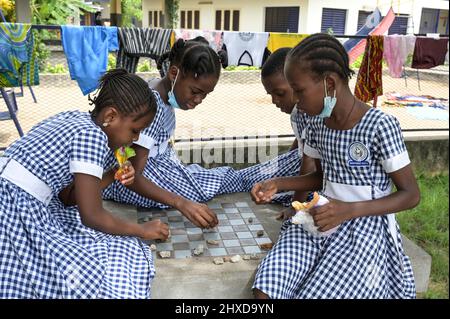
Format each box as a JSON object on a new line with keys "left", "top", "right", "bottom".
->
{"left": 138, "top": 201, "right": 272, "bottom": 259}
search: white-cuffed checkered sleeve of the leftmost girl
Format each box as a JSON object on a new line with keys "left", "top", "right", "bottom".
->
{"left": 69, "top": 129, "right": 109, "bottom": 179}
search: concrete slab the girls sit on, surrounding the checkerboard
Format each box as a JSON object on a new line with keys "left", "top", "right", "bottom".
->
{"left": 105, "top": 193, "right": 431, "bottom": 299}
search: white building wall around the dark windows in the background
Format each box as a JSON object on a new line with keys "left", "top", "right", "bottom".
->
{"left": 142, "top": 0, "right": 449, "bottom": 34}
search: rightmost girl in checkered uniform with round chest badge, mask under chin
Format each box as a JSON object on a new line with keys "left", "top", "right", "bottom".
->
{"left": 252, "top": 34, "right": 420, "bottom": 298}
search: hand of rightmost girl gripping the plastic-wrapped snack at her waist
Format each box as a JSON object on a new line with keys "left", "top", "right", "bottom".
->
{"left": 309, "top": 199, "right": 352, "bottom": 232}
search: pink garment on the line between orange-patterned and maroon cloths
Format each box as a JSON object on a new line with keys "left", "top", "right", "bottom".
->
{"left": 383, "top": 34, "right": 416, "bottom": 78}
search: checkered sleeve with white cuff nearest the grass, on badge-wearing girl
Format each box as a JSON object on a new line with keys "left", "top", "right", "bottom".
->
{"left": 374, "top": 114, "right": 411, "bottom": 173}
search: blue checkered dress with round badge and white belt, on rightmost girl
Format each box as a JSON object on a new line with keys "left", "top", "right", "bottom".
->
{"left": 253, "top": 109, "right": 415, "bottom": 299}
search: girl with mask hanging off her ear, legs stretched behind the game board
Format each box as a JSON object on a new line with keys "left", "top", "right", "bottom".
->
{"left": 103, "top": 37, "right": 316, "bottom": 228}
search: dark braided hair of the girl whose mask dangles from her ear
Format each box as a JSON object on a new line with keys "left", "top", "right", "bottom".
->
{"left": 157, "top": 37, "right": 221, "bottom": 78}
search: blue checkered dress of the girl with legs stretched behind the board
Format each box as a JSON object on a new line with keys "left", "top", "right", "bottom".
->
{"left": 103, "top": 91, "right": 310, "bottom": 208}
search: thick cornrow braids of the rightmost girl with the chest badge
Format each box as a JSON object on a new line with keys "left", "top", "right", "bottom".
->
{"left": 287, "top": 33, "right": 354, "bottom": 81}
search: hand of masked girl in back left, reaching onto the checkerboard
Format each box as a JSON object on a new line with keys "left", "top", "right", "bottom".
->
{"left": 177, "top": 199, "right": 219, "bottom": 228}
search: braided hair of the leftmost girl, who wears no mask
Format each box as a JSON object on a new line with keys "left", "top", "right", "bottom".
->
{"left": 88, "top": 68, "right": 156, "bottom": 121}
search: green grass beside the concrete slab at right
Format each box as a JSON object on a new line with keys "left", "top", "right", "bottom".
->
{"left": 397, "top": 173, "right": 449, "bottom": 299}
